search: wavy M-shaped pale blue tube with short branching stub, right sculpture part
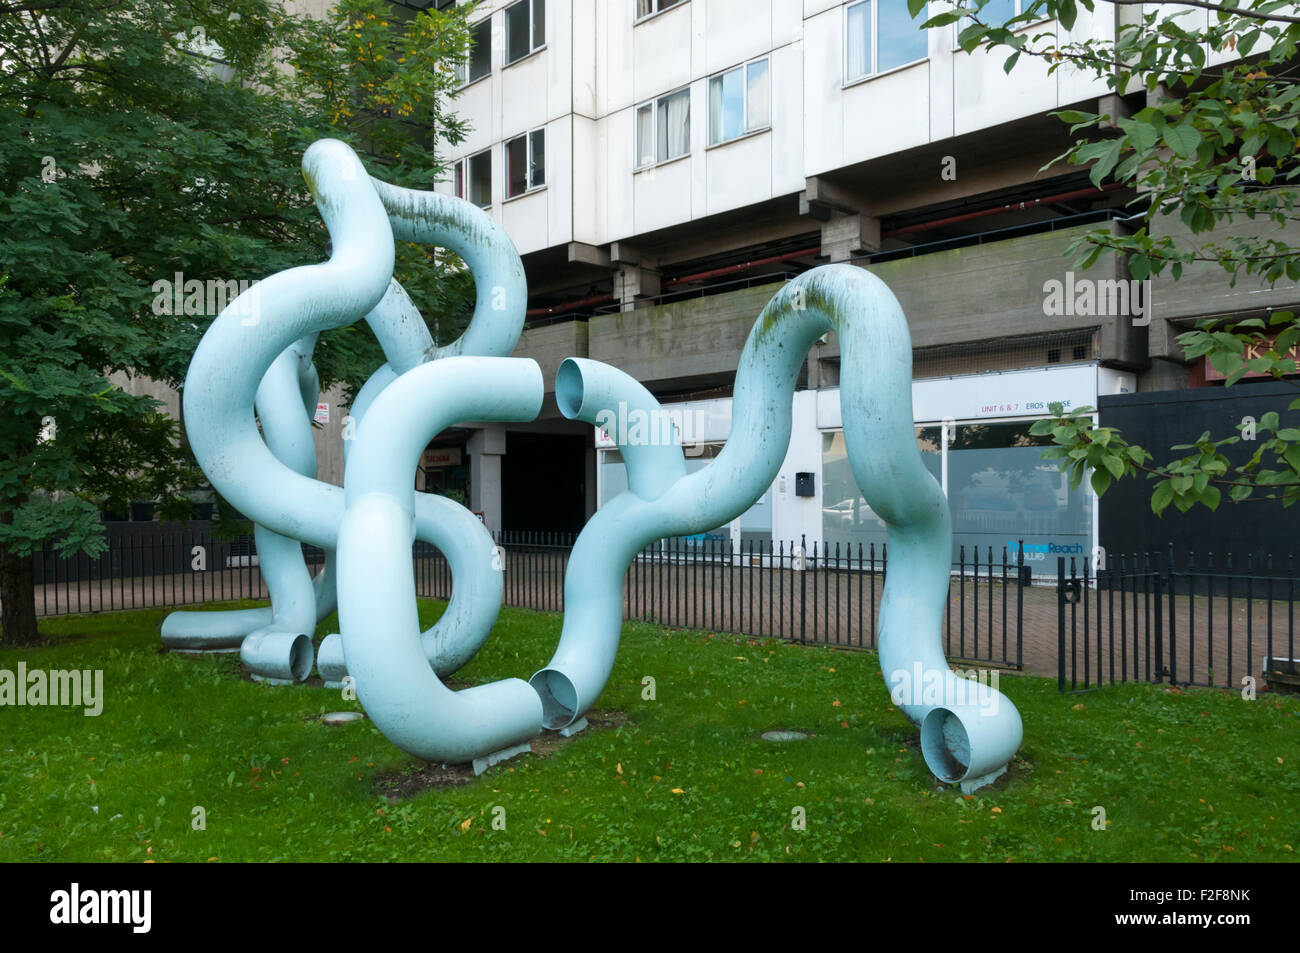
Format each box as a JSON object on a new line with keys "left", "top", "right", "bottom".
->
{"left": 532, "top": 265, "right": 1022, "bottom": 787}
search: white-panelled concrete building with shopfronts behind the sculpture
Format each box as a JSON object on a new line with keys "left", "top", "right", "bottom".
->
{"left": 403, "top": 0, "right": 1300, "bottom": 561}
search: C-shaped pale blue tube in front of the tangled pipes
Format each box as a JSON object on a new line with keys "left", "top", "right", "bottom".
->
{"left": 338, "top": 358, "right": 545, "bottom": 762}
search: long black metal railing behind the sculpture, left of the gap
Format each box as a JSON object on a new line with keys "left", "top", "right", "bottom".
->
{"left": 34, "top": 524, "right": 1030, "bottom": 668}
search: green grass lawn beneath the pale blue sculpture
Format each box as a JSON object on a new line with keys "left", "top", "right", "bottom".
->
{"left": 0, "top": 602, "right": 1300, "bottom": 862}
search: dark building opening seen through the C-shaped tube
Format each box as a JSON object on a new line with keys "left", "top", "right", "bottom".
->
{"left": 501, "top": 433, "right": 588, "bottom": 533}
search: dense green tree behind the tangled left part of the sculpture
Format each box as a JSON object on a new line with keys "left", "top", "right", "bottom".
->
{"left": 0, "top": 0, "right": 472, "bottom": 644}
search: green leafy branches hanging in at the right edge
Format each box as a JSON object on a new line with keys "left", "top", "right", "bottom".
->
{"left": 907, "top": 0, "right": 1300, "bottom": 514}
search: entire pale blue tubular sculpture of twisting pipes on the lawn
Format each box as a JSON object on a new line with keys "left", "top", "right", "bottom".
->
{"left": 175, "top": 133, "right": 1022, "bottom": 789}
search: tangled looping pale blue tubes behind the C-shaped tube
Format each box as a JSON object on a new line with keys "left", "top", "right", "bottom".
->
{"left": 175, "top": 140, "right": 527, "bottom": 684}
